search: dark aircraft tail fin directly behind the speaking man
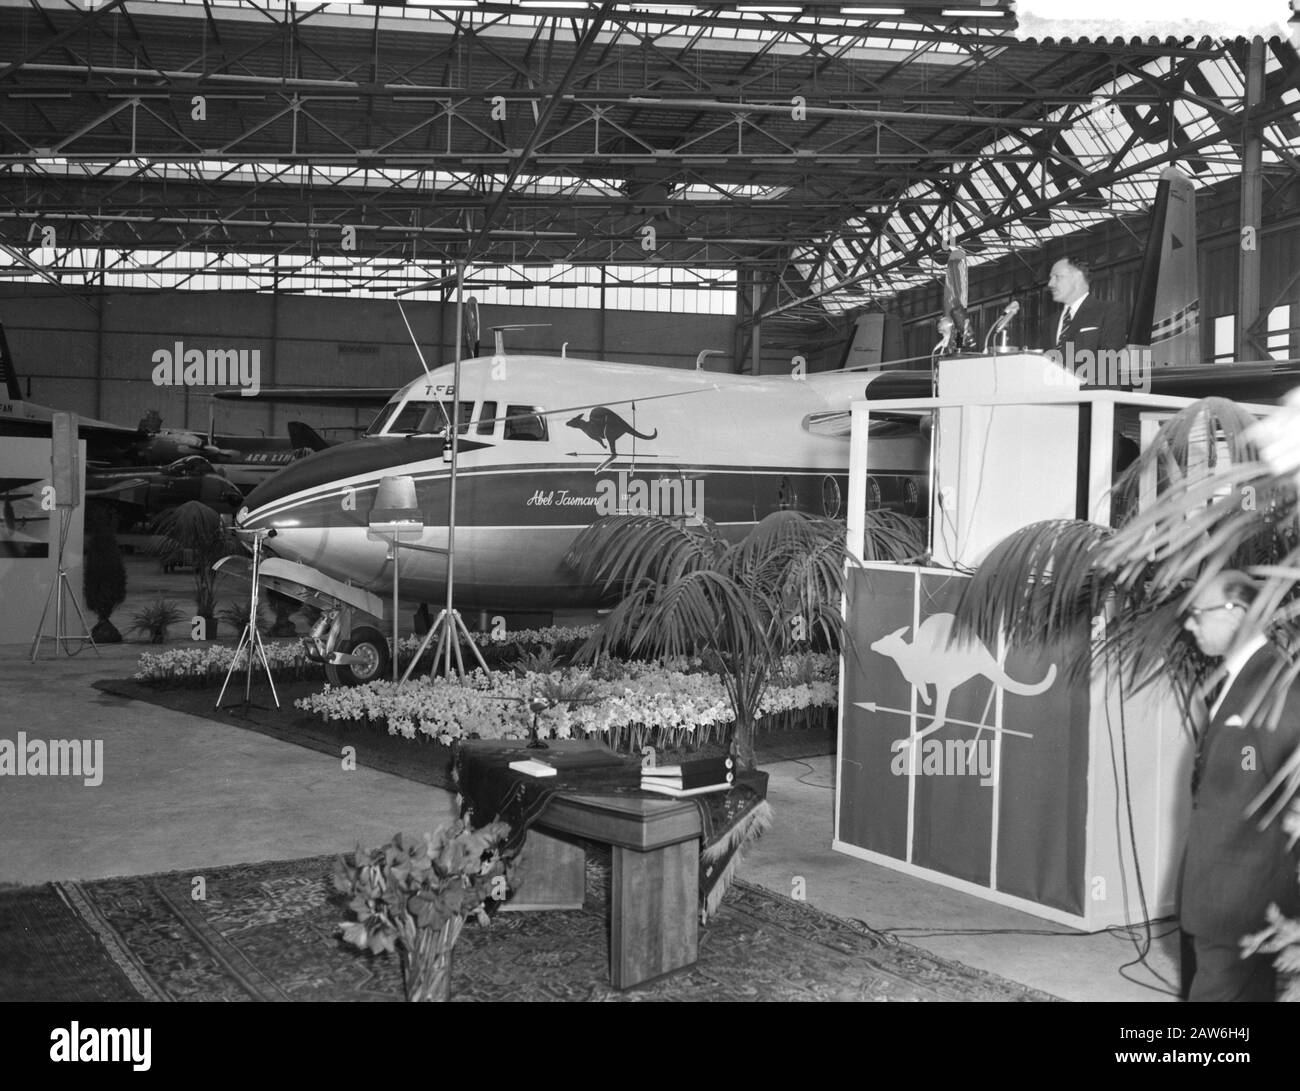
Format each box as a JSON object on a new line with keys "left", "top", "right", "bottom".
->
{"left": 1128, "top": 166, "right": 1204, "bottom": 368}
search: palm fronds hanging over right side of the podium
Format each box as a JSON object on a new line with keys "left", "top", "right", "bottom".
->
{"left": 954, "top": 398, "right": 1300, "bottom": 702}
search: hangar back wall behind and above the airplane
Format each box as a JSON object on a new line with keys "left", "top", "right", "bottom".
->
{"left": 0, "top": 287, "right": 767, "bottom": 440}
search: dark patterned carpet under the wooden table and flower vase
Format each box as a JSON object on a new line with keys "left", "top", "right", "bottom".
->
{"left": 0, "top": 849, "right": 1054, "bottom": 1001}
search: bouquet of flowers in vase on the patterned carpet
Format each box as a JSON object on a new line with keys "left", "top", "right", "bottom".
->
{"left": 334, "top": 819, "right": 514, "bottom": 1001}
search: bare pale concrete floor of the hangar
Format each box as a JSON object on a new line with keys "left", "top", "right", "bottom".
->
{"left": 0, "top": 546, "right": 1177, "bottom": 1001}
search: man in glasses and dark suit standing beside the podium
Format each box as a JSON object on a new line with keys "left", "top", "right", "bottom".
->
{"left": 1179, "top": 571, "right": 1300, "bottom": 1001}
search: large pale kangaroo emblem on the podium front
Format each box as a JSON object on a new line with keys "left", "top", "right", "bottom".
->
{"left": 871, "top": 614, "right": 1056, "bottom": 743}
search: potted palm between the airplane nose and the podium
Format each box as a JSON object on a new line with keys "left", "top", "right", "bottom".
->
{"left": 566, "top": 511, "right": 923, "bottom": 769}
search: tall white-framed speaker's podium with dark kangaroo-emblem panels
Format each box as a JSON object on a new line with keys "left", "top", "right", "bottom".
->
{"left": 833, "top": 354, "right": 1232, "bottom": 931}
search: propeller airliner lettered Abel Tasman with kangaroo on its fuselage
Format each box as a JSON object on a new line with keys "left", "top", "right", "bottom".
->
{"left": 237, "top": 351, "right": 928, "bottom": 681}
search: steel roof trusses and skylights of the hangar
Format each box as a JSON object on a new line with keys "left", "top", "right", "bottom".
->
{"left": 0, "top": 0, "right": 1300, "bottom": 321}
